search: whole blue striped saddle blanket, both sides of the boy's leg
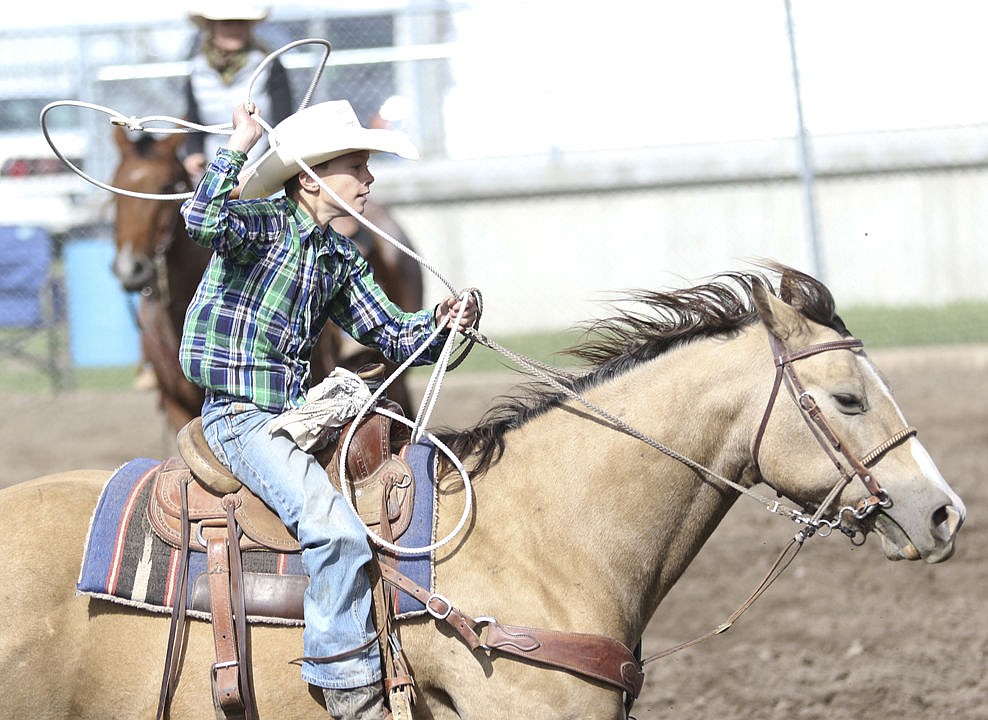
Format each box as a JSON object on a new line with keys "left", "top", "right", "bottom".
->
{"left": 76, "top": 442, "right": 436, "bottom": 625}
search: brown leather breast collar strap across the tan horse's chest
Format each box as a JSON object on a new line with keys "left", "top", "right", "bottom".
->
{"left": 380, "top": 563, "right": 645, "bottom": 698}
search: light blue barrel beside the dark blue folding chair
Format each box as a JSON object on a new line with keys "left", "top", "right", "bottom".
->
{"left": 63, "top": 238, "right": 141, "bottom": 367}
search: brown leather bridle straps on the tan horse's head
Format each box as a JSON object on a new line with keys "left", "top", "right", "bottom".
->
{"left": 752, "top": 333, "right": 916, "bottom": 520}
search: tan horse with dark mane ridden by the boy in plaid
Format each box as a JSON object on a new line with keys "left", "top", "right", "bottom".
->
{"left": 0, "top": 272, "right": 965, "bottom": 720}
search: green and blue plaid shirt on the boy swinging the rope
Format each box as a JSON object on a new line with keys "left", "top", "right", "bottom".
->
{"left": 179, "top": 149, "right": 442, "bottom": 412}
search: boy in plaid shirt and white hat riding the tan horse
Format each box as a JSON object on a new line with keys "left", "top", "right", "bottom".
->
{"left": 179, "top": 101, "right": 477, "bottom": 718}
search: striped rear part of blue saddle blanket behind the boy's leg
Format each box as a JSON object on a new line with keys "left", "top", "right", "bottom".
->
{"left": 76, "top": 458, "right": 305, "bottom": 625}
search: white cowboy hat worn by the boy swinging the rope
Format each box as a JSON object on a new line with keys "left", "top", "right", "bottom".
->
{"left": 240, "top": 100, "right": 419, "bottom": 200}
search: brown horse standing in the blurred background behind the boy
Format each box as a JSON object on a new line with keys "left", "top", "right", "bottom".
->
{"left": 112, "top": 127, "right": 423, "bottom": 430}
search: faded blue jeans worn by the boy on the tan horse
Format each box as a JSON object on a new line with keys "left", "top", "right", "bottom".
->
{"left": 202, "top": 396, "right": 381, "bottom": 688}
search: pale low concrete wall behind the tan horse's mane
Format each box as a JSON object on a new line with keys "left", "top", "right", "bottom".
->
{"left": 374, "top": 128, "right": 988, "bottom": 332}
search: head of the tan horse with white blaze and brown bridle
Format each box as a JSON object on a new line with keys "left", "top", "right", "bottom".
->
{"left": 752, "top": 271, "right": 966, "bottom": 563}
